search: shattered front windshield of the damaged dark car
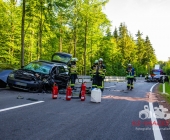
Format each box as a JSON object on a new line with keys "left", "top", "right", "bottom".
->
{"left": 23, "top": 62, "right": 52, "bottom": 74}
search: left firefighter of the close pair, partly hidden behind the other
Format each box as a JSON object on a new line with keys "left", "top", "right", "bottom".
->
{"left": 90, "top": 60, "right": 98, "bottom": 89}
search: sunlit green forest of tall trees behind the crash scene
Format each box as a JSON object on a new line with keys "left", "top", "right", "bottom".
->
{"left": 0, "top": 0, "right": 170, "bottom": 76}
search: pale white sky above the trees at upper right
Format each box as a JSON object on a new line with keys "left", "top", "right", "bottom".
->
{"left": 103, "top": 0, "right": 170, "bottom": 61}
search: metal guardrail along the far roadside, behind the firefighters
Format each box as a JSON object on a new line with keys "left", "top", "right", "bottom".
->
{"left": 76, "top": 75, "right": 145, "bottom": 83}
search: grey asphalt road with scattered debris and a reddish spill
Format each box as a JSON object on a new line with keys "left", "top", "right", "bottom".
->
{"left": 0, "top": 80, "right": 170, "bottom": 140}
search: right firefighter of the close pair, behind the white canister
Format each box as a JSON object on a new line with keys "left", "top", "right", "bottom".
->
{"left": 97, "top": 58, "right": 106, "bottom": 92}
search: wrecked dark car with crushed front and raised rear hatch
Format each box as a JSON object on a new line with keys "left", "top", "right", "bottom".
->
{"left": 7, "top": 53, "right": 71, "bottom": 92}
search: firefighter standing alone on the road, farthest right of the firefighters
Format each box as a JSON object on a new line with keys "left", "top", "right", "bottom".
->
{"left": 126, "top": 64, "right": 136, "bottom": 90}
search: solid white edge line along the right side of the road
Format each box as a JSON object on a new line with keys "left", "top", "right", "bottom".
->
{"left": 149, "top": 83, "right": 163, "bottom": 140}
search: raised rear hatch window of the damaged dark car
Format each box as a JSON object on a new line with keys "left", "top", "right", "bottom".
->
{"left": 52, "top": 54, "right": 71, "bottom": 63}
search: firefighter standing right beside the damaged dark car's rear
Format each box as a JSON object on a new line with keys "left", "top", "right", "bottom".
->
{"left": 69, "top": 58, "right": 78, "bottom": 89}
